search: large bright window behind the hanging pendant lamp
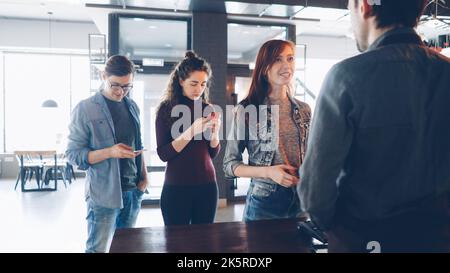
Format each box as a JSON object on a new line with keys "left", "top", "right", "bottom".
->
{"left": 3, "top": 53, "right": 89, "bottom": 152}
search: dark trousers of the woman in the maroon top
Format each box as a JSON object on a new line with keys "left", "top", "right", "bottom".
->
{"left": 161, "top": 183, "right": 218, "bottom": 226}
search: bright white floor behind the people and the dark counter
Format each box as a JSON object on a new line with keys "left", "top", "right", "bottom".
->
{"left": 0, "top": 179, "right": 244, "bottom": 252}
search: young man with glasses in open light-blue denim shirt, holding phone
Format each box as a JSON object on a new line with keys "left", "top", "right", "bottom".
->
{"left": 66, "top": 55, "right": 148, "bottom": 252}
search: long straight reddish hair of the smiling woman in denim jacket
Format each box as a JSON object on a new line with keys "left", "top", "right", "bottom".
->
{"left": 241, "top": 40, "right": 295, "bottom": 107}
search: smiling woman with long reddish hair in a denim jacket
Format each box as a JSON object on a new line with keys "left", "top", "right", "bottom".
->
{"left": 224, "top": 40, "right": 311, "bottom": 221}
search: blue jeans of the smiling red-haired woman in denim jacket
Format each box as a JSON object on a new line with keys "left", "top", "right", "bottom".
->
{"left": 244, "top": 181, "right": 301, "bottom": 222}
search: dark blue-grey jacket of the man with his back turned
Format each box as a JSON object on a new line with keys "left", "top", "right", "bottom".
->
{"left": 299, "top": 28, "right": 450, "bottom": 230}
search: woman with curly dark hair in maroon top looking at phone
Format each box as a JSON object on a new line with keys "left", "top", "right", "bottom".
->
{"left": 156, "top": 51, "right": 221, "bottom": 225}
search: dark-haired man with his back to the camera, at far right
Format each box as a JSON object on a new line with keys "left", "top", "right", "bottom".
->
{"left": 298, "top": 0, "right": 450, "bottom": 252}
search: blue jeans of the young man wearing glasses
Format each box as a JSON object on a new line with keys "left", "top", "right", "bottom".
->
{"left": 86, "top": 188, "right": 144, "bottom": 253}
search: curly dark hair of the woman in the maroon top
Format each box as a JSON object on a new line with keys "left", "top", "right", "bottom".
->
{"left": 156, "top": 50, "right": 212, "bottom": 118}
